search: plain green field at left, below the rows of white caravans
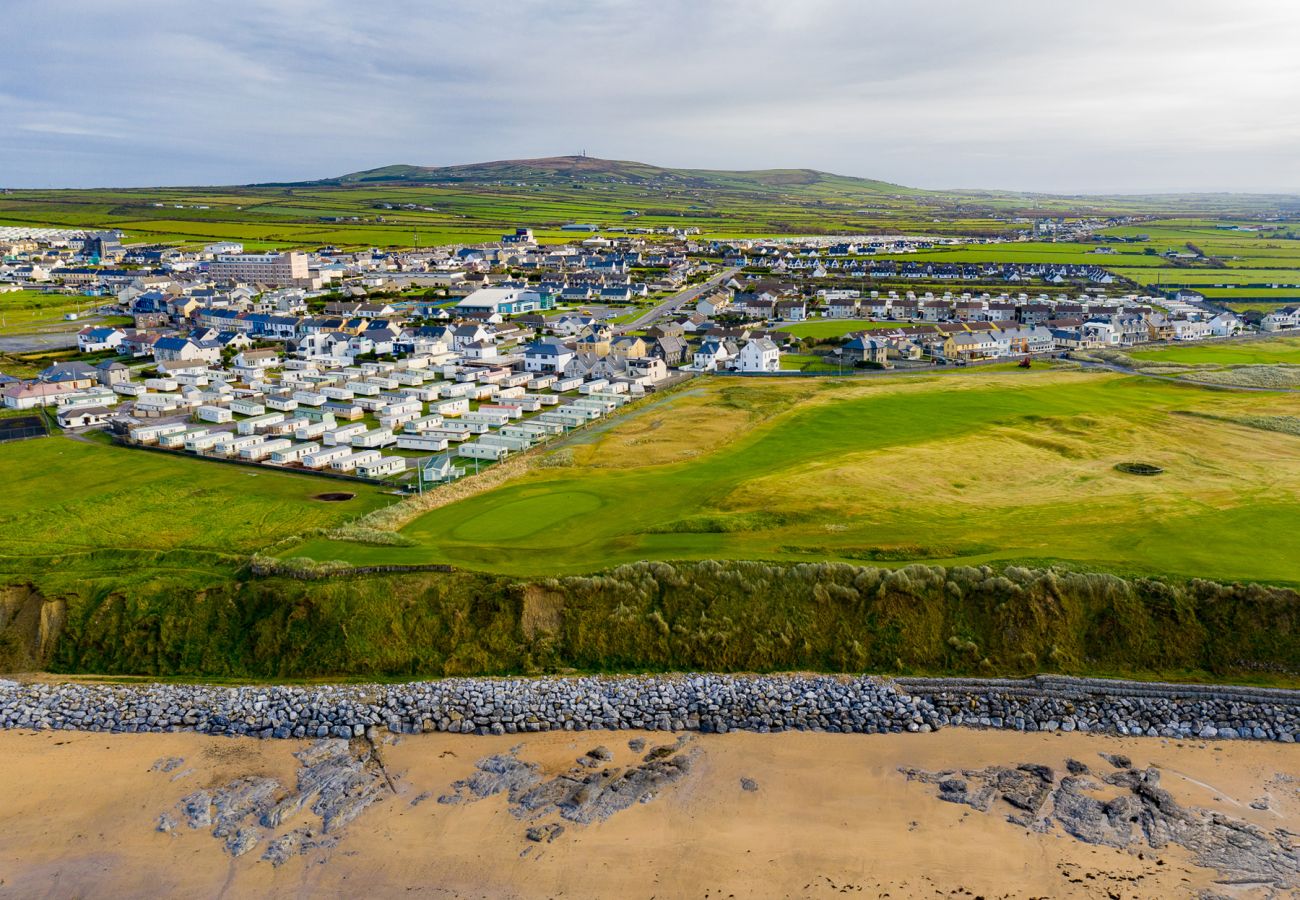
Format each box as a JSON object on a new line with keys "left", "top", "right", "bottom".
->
{"left": 0, "top": 437, "right": 386, "bottom": 570}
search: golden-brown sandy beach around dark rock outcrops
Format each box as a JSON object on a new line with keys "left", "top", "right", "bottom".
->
{"left": 0, "top": 728, "right": 1300, "bottom": 900}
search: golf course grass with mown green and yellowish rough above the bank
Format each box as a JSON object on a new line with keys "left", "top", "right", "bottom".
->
{"left": 282, "top": 371, "right": 1300, "bottom": 584}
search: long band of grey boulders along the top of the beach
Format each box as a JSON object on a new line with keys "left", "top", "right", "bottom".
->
{"left": 0, "top": 675, "right": 1300, "bottom": 743}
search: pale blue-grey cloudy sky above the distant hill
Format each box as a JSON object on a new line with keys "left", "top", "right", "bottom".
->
{"left": 0, "top": 0, "right": 1300, "bottom": 192}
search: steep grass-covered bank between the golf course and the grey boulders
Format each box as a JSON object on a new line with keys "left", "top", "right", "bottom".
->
{"left": 17, "top": 562, "right": 1300, "bottom": 684}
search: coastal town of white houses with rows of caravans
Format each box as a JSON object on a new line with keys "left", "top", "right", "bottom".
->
{"left": 0, "top": 228, "right": 1300, "bottom": 489}
